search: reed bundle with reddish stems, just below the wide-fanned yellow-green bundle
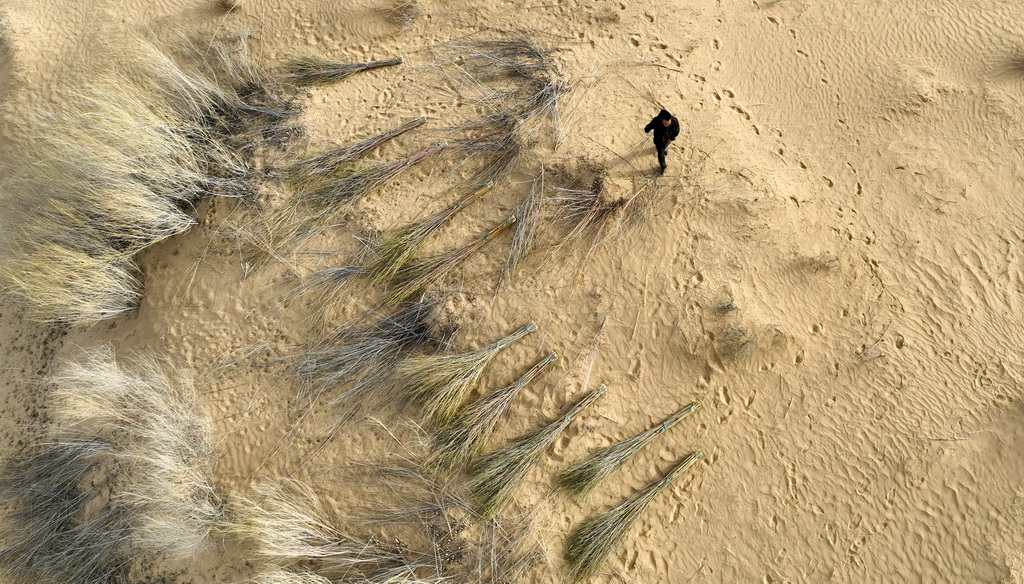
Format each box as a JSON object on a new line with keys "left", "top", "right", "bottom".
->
{"left": 427, "top": 352, "right": 558, "bottom": 470}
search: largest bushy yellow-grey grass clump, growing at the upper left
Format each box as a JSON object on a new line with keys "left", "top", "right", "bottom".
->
{"left": 0, "top": 29, "right": 307, "bottom": 326}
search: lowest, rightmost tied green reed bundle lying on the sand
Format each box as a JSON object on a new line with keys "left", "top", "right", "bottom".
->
{"left": 565, "top": 450, "right": 703, "bottom": 582}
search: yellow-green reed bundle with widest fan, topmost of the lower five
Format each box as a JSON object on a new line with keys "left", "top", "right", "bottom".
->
{"left": 393, "top": 322, "right": 537, "bottom": 424}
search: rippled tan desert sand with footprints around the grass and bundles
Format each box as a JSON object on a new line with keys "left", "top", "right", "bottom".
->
{"left": 0, "top": 0, "right": 1024, "bottom": 584}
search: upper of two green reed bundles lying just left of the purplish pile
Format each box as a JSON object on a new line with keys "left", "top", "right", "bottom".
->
{"left": 365, "top": 183, "right": 492, "bottom": 284}
